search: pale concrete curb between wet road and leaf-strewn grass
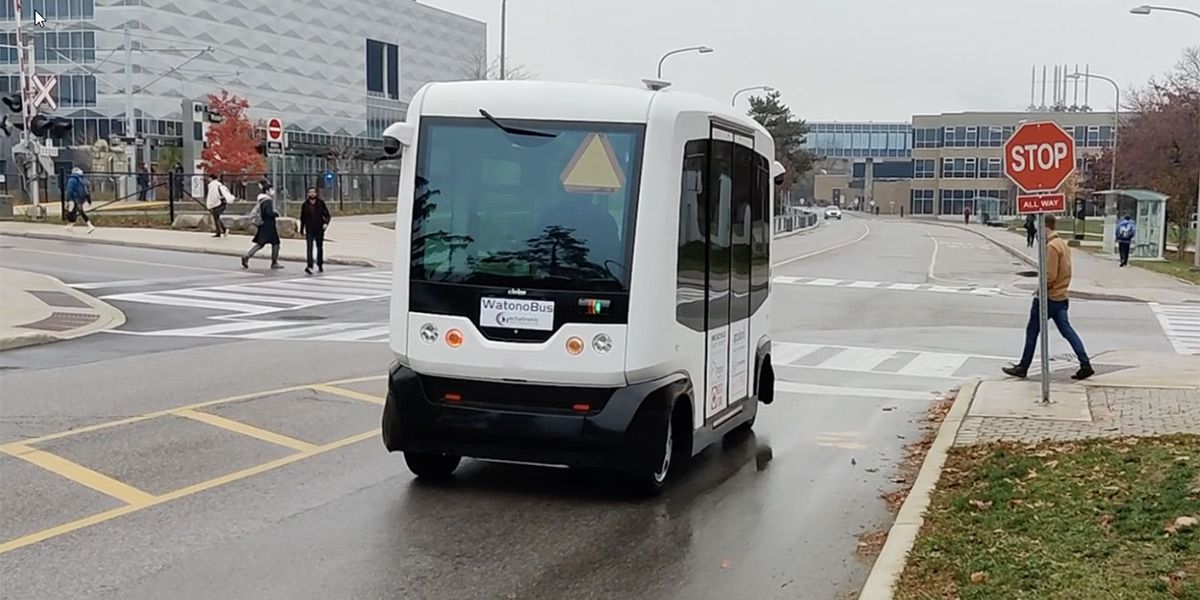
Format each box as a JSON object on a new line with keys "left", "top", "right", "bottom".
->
{"left": 858, "top": 379, "right": 980, "bottom": 600}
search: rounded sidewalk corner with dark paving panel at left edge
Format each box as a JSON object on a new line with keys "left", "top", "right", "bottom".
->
{"left": 0, "top": 268, "right": 125, "bottom": 350}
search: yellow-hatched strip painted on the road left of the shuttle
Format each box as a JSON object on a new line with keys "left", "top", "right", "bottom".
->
{"left": 0, "top": 376, "right": 386, "bottom": 554}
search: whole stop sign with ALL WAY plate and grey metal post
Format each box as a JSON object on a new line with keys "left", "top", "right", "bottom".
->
{"left": 1004, "top": 121, "right": 1075, "bottom": 402}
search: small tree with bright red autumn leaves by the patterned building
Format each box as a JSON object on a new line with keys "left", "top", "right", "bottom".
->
{"left": 200, "top": 90, "right": 266, "bottom": 180}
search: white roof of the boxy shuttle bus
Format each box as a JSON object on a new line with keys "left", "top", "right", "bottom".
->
{"left": 409, "top": 80, "right": 769, "bottom": 137}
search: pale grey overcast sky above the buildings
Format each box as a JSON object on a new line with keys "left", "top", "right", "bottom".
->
{"left": 420, "top": 0, "right": 1200, "bottom": 121}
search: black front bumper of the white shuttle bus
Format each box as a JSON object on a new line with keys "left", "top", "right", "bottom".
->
{"left": 383, "top": 365, "right": 690, "bottom": 473}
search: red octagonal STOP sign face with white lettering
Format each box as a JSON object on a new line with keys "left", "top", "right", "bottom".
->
{"left": 1004, "top": 121, "right": 1075, "bottom": 192}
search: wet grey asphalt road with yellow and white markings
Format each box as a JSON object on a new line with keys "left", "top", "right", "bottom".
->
{"left": 0, "top": 216, "right": 1170, "bottom": 600}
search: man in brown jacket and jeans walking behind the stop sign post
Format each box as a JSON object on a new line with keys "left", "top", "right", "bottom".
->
{"left": 1004, "top": 215, "right": 1096, "bottom": 379}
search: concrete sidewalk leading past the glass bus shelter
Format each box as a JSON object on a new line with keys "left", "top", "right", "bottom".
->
{"left": 938, "top": 221, "right": 1200, "bottom": 304}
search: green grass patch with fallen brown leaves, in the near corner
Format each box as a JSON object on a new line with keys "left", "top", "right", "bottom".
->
{"left": 895, "top": 436, "right": 1200, "bottom": 600}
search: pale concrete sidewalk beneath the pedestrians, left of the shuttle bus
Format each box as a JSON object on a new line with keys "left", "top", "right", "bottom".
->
{"left": 0, "top": 215, "right": 395, "bottom": 266}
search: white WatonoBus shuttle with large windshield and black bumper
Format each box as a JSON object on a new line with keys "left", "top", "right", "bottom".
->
{"left": 383, "top": 82, "right": 782, "bottom": 493}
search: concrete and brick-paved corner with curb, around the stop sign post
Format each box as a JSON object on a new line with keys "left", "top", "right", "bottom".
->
{"left": 859, "top": 350, "right": 1200, "bottom": 600}
